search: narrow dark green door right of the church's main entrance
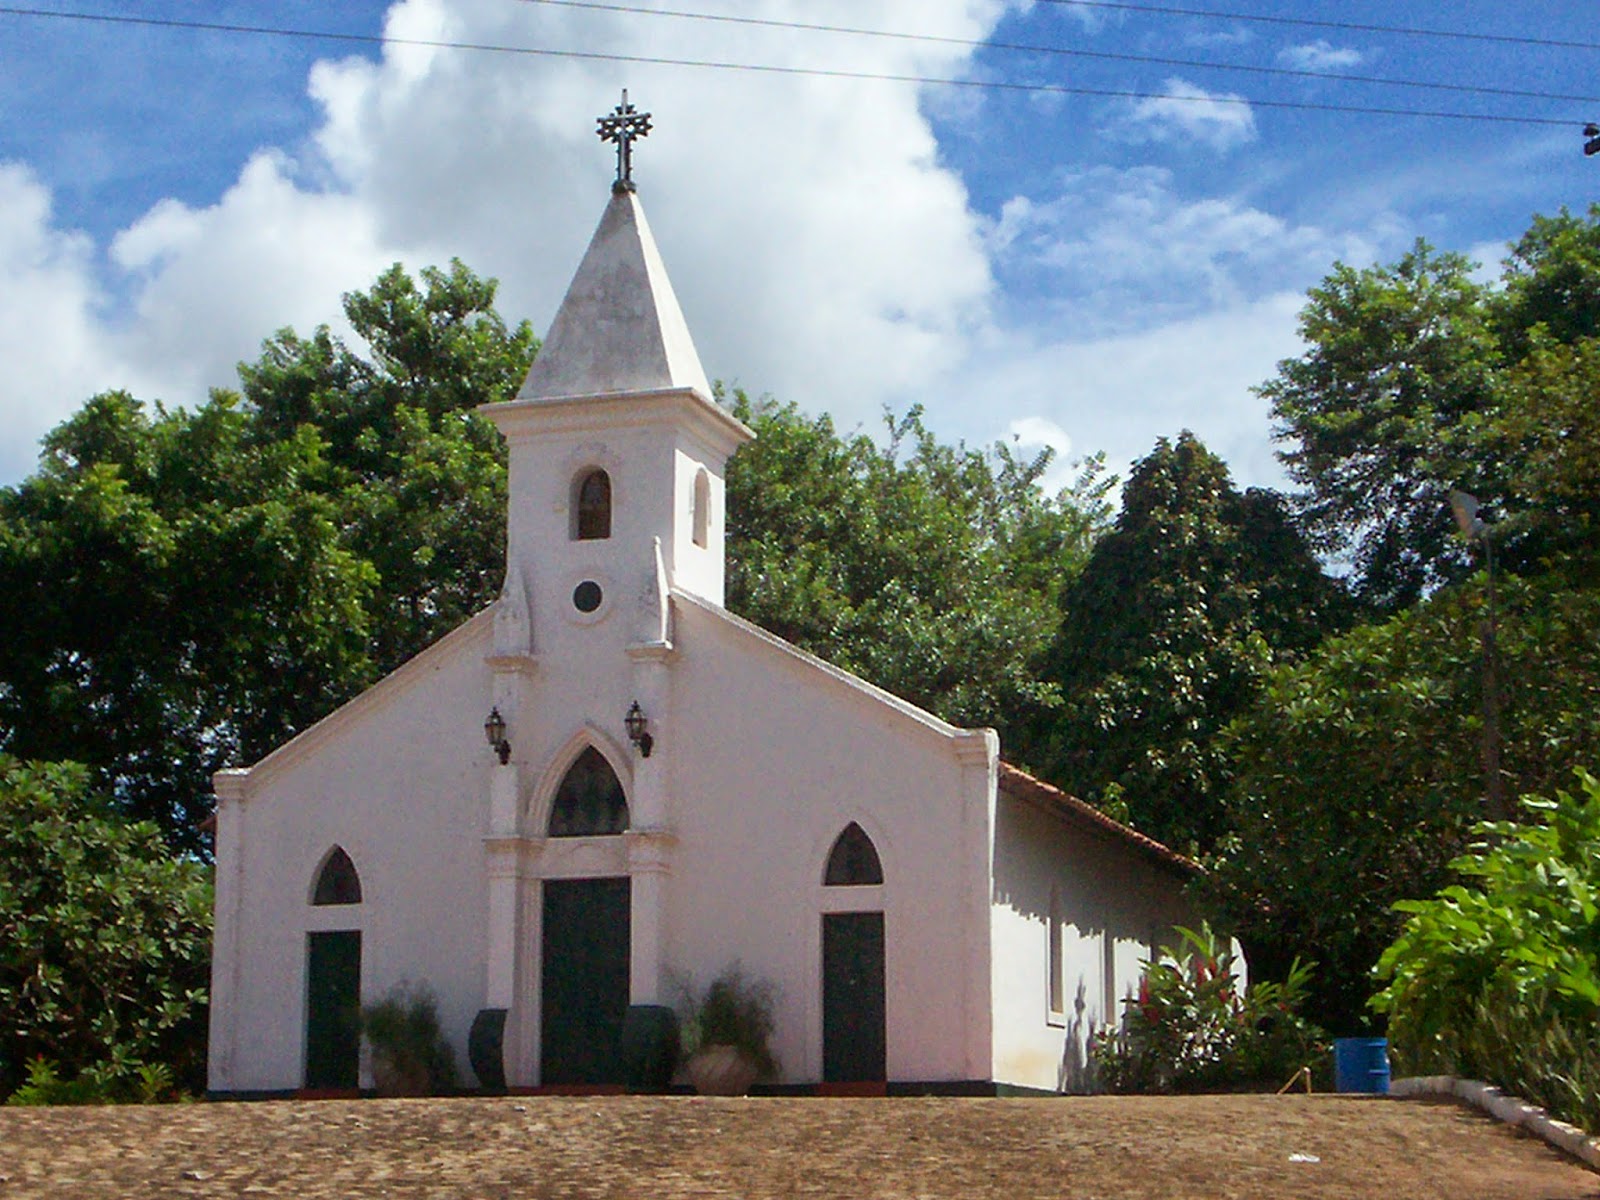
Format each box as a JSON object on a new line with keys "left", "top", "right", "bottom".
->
{"left": 822, "top": 912, "right": 888, "bottom": 1083}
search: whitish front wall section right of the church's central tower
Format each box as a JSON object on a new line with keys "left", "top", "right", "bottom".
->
{"left": 658, "top": 602, "right": 995, "bottom": 1083}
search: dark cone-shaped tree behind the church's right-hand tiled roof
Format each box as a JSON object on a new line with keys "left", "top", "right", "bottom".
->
{"left": 1037, "top": 430, "right": 1342, "bottom": 846}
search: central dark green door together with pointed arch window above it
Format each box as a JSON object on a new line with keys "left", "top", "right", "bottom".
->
{"left": 539, "top": 746, "right": 632, "bottom": 1088}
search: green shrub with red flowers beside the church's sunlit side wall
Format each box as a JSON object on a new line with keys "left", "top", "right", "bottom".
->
{"left": 1090, "top": 925, "right": 1326, "bottom": 1091}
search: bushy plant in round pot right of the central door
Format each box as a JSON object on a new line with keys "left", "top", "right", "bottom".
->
{"left": 683, "top": 963, "right": 778, "bottom": 1096}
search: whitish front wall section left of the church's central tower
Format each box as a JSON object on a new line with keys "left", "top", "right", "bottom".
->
{"left": 210, "top": 618, "right": 494, "bottom": 1091}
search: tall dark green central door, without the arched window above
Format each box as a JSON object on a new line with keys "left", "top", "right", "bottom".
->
{"left": 539, "top": 877, "right": 632, "bottom": 1085}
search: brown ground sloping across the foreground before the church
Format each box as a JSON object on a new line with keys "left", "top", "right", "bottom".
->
{"left": 0, "top": 1096, "right": 1600, "bottom": 1200}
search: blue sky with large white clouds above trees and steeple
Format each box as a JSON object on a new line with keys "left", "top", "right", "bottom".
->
{"left": 0, "top": 0, "right": 1600, "bottom": 485}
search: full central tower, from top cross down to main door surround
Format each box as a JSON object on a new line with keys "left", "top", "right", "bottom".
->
{"left": 480, "top": 101, "right": 754, "bottom": 1062}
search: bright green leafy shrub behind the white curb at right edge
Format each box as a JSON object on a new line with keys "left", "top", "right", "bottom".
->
{"left": 1371, "top": 771, "right": 1600, "bottom": 1130}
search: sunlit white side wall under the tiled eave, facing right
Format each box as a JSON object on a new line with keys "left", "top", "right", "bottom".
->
{"left": 992, "top": 789, "right": 1198, "bottom": 1091}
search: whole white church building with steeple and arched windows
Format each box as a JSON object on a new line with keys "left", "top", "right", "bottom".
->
{"left": 210, "top": 101, "right": 1195, "bottom": 1096}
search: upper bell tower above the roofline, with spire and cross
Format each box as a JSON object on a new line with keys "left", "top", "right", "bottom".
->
{"left": 482, "top": 101, "right": 754, "bottom": 668}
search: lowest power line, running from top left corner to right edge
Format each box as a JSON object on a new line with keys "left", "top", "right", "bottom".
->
{"left": 0, "top": 5, "right": 1582, "bottom": 128}
